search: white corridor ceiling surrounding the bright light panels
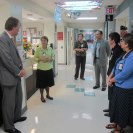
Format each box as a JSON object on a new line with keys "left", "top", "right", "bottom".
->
{"left": 0, "top": 0, "right": 124, "bottom": 23}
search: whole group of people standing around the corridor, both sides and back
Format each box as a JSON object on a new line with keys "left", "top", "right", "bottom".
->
{"left": 0, "top": 17, "right": 133, "bottom": 133}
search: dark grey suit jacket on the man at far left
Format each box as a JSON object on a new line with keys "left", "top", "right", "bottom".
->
{"left": 0, "top": 32, "right": 22, "bottom": 86}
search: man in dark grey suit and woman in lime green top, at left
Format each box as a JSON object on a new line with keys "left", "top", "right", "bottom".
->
{"left": 0, "top": 17, "right": 54, "bottom": 133}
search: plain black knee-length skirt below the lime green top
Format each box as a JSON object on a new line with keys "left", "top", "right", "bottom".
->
{"left": 36, "top": 69, "right": 54, "bottom": 89}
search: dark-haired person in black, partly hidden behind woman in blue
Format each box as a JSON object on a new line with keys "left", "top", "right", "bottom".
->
{"left": 103, "top": 32, "right": 123, "bottom": 116}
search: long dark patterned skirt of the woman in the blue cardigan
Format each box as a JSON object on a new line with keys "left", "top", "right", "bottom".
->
{"left": 110, "top": 86, "right": 133, "bottom": 128}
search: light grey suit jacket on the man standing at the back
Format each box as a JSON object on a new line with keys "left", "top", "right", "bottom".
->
{"left": 93, "top": 39, "right": 110, "bottom": 66}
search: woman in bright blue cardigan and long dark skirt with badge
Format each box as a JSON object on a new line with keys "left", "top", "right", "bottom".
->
{"left": 108, "top": 34, "right": 133, "bottom": 133}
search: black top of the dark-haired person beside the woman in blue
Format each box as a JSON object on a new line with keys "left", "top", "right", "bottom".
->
{"left": 107, "top": 44, "right": 123, "bottom": 76}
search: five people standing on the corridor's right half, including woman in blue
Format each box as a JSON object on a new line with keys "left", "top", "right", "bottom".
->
{"left": 74, "top": 26, "right": 133, "bottom": 133}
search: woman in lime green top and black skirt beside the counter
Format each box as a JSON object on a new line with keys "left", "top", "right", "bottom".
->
{"left": 34, "top": 36, "right": 54, "bottom": 102}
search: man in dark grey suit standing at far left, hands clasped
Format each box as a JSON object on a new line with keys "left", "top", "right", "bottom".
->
{"left": 0, "top": 17, "right": 26, "bottom": 133}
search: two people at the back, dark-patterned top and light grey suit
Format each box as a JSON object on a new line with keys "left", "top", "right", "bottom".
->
{"left": 74, "top": 30, "right": 110, "bottom": 91}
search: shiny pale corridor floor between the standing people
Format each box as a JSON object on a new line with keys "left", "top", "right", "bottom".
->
{"left": 0, "top": 47, "right": 132, "bottom": 133}
